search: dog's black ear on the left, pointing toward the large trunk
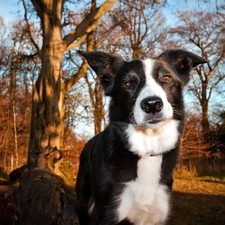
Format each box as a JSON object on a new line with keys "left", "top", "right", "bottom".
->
{"left": 78, "top": 51, "right": 124, "bottom": 95}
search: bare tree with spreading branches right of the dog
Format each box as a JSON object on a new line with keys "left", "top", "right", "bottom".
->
{"left": 171, "top": 11, "right": 225, "bottom": 139}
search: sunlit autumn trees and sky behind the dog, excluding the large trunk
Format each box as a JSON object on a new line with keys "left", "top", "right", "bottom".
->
{"left": 0, "top": 1, "right": 225, "bottom": 178}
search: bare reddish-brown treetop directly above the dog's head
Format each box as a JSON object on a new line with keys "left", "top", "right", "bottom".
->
{"left": 107, "top": 0, "right": 166, "bottom": 60}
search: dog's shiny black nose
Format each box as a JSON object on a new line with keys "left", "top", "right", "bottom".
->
{"left": 141, "top": 96, "right": 163, "bottom": 114}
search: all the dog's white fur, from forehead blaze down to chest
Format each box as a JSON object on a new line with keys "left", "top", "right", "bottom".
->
{"left": 117, "top": 59, "right": 179, "bottom": 225}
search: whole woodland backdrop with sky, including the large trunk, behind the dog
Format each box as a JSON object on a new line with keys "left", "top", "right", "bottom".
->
{"left": 0, "top": 0, "right": 225, "bottom": 224}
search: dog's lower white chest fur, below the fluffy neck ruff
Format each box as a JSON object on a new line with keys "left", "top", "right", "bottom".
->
{"left": 118, "top": 156, "right": 169, "bottom": 225}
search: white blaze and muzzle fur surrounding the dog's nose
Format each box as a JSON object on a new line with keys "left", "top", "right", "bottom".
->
{"left": 134, "top": 59, "right": 173, "bottom": 129}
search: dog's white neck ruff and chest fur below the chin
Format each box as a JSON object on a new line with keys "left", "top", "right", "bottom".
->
{"left": 118, "top": 124, "right": 178, "bottom": 225}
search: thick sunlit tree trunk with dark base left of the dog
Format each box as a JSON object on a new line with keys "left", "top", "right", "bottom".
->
{"left": 18, "top": 0, "right": 77, "bottom": 225}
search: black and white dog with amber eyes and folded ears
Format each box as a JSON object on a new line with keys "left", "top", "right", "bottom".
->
{"left": 76, "top": 49, "right": 206, "bottom": 225}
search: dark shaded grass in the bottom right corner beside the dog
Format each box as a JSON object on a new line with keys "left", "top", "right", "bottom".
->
{"left": 167, "top": 190, "right": 225, "bottom": 225}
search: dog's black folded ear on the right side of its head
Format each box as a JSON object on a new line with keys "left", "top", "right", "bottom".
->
{"left": 160, "top": 49, "right": 207, "bottom": 84}
